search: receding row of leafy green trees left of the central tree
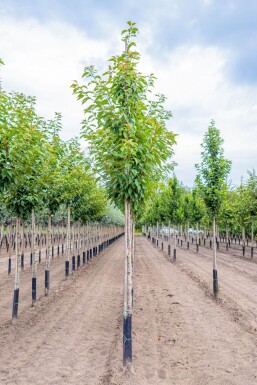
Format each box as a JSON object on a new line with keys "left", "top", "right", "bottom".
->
{"left": 0, "top": 61, "right": 124, "bottom": 318}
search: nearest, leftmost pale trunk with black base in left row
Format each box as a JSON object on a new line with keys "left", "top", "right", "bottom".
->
{"left": 12, "top": 217, "right": 21, "bottom": 320}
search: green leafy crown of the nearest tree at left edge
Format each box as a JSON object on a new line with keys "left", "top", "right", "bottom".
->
{"left": 0, "top": 93, "right": 47, "bottom": 218}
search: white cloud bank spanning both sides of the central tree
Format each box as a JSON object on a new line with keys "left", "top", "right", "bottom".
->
{"left": 0, "top": 19, "right": 257, "bottom": 184}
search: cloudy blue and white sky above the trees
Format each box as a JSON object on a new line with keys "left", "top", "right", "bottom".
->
{"left": 0, "top": 0, "right": 257, "bottom": 186}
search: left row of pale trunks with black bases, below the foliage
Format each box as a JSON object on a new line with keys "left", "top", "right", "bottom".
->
{"left": 0, "top": 220, "right": 124, "bottom": 319}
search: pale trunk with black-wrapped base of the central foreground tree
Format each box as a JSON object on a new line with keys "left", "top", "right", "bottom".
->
{"left": 123, "top": 200, "right": 133, "bottom": 368}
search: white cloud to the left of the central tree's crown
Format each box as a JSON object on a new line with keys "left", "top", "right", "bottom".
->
{"left": 0, "top": 19, "right": 112, "bottom": 138}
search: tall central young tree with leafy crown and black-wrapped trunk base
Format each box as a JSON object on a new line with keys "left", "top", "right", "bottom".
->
{"left": 72, "top": 22, "right": 175, "bottom": 367}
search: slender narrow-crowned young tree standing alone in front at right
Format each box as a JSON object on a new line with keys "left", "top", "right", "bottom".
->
{"left": 196, "top": 120, "right": 231, "bottom": 297}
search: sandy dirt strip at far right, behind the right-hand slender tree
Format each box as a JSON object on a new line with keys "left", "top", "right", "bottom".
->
{"left": 166, "top": 238, "right": 257, "bottom": 334}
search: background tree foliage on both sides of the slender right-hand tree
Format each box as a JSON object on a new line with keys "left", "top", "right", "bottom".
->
{"left": 138, "top": 170, "right": 257, "bottom": 239}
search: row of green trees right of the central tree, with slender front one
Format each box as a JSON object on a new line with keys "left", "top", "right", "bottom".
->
{"left": 139, "top": 121, "right": 257, "bottom": 296}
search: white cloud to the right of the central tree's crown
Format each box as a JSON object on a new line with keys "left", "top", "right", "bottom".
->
{"left": 138, "top": 46, "right": 257, "bottom": 185}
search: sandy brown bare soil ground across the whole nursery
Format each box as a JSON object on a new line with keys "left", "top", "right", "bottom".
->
{"left": 0, "top": 236, "right": 257, "bottom": 385}
